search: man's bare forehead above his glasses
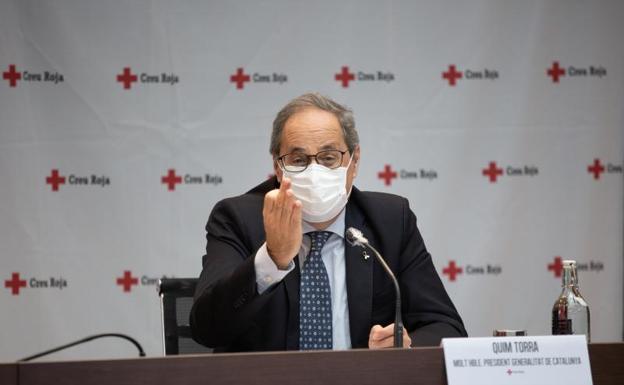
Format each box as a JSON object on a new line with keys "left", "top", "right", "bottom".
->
{"left": 280, "top": 108, "right": 346, "bottom": 154}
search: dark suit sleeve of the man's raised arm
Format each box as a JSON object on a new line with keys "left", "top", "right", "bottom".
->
{"left": 190, "top": 200, "right": 280, "bottom": 348}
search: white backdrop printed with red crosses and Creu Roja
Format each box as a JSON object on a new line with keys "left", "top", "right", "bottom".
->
{"left": 0, "top": 0, "right": 624, "bottom": 361}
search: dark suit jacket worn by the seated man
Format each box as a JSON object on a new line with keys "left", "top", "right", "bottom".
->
{"left": 190, "top": 178, "right": 466, "bottom": 351}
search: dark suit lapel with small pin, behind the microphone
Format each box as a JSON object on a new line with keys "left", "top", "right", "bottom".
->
{"left": 345, "top": 198, "right": 374, "bottom": 348}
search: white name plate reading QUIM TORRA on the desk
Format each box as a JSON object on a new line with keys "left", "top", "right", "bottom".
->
{"left": 442, "top": 335, "right": 592, "bottom": 385}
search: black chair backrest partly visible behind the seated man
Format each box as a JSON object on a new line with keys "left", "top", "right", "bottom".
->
{"left": 158, "top": 278, "right": 212, "bottom": 356}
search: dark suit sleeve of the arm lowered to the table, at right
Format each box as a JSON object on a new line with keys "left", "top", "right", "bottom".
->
{"left": 399, "top": 199, "right": 467, "bottom": 346}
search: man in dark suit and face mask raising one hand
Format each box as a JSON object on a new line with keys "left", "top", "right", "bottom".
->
{"left": 190, "top": 94, "right": 466, "bottom": 351}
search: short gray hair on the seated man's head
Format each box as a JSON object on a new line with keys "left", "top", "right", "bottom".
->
{"left": 269, "top": 93, "right": 360, "bottom": 158}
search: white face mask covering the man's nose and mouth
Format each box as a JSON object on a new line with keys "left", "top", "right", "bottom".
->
{"left": 284, "top": 156, "right": 353, "bottom": 223}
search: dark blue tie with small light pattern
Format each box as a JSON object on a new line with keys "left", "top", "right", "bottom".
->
{"left": 299, "top": 231, "right": 332, "bottom": 350}
